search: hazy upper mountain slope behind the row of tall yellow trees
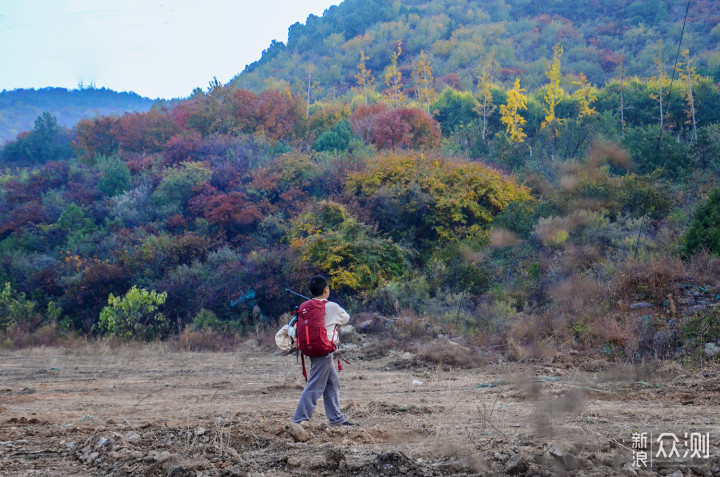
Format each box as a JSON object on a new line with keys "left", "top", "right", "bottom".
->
{"left": 234, "top": 0, "right": 720, "bottom": 97}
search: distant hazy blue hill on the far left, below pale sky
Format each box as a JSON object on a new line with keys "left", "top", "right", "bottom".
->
{"left": 0, "top": 88, "right": 154, "bottom": 144}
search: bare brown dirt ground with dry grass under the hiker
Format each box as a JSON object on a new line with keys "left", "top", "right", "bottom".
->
{"left": 0, "top": 341, "right": 720, "bottom": 477}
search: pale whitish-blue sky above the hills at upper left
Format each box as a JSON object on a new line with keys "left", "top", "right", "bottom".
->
{"left": 0, "top": 0, "right": 341, "bottom": 99}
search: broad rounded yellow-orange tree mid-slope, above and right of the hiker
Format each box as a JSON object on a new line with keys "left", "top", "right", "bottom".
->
{"left": 347, "top": 154, "right": 530, "bottom": 247}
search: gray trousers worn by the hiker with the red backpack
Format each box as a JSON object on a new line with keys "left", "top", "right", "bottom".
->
{"left": 293, "top": 353, "right": 345, "bottom": 425}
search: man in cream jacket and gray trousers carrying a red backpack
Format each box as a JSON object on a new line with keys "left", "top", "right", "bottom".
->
{"left": 293, "top": 275, "right": 354, "bottom": 426}
